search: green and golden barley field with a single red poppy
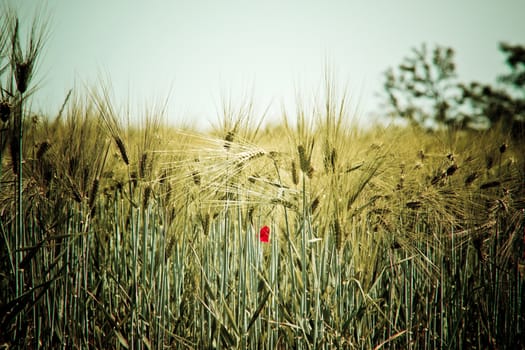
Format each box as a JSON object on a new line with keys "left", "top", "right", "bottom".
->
{"left": 0, "top": 8, "right": 525, "bottom": 349}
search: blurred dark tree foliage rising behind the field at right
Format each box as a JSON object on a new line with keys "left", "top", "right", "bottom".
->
{"left": 384, "top": 43, "right": 525, "bottom": 137}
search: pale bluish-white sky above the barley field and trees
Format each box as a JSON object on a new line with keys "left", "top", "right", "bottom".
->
{"left": 10, "top": 0, "right": 525, "bottom": 127}
